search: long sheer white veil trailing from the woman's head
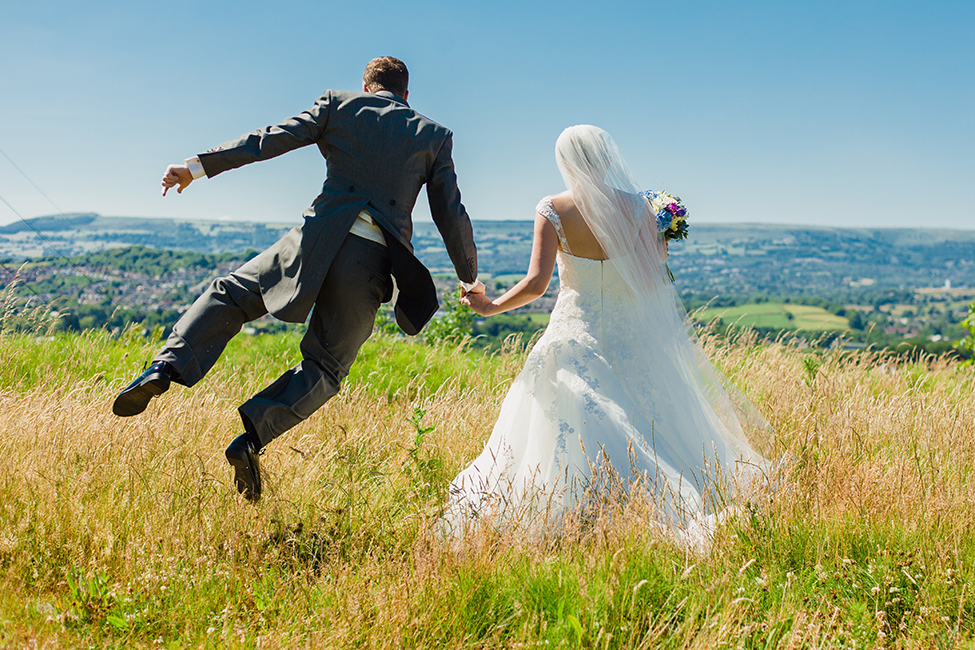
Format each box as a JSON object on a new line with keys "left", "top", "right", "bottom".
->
{"left": 555, "top": 125, "right": 770, "bottom": 473}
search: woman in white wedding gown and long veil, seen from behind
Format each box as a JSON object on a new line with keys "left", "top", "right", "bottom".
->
{"left": 445, "top": 125, "right": 767, "bottom": 543}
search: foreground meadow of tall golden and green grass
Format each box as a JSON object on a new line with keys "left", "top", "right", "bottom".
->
{"left": 0, "top": 332, "right": 975, "bottom": 648}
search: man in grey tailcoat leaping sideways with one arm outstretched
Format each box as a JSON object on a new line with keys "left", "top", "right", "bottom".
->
{"left": 112, "top": 57, "right": 484, "bottom": 501}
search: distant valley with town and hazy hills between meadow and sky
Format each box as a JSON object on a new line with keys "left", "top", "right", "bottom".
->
{"left": 0, "top": 214, "right": 975, "bottom": 352}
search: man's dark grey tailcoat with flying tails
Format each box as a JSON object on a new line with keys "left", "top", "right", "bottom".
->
{"left": 200, "top": 90, "right": 477, "bottom": 334}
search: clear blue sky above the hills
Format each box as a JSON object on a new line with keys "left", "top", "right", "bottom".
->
{"left": 0, "top": 0, "right": 975, "bottom": 229}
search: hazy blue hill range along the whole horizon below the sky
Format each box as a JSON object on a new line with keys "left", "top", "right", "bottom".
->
{"left": 0, "top": 213, "right": 975, "bottom": 295}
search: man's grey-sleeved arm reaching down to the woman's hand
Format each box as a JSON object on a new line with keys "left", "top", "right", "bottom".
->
{"left": 427, "top": 131, "right": 477, "bottom": 284}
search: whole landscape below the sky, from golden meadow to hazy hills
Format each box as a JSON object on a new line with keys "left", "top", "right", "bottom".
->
{"left": 0, "top": 211, "right": 975, "bottom": 648}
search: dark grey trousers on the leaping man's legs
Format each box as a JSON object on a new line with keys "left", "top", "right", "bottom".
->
{"left": 154, "top": 234, "right": 393, "bottom": 447}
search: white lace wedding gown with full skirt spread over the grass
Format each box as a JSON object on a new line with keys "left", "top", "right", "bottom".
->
{"left": 444, "top": 124, "right": 765, "bottom": 546}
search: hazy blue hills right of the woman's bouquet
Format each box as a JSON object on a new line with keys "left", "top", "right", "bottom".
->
{"left": 671, "top": 224, "right": 975, "bottom": 300}
